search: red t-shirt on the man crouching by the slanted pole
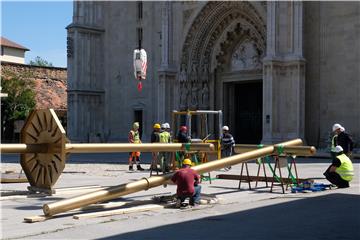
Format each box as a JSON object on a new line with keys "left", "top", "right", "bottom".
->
{"left": 171, "top": 168, "right": 200, "bottom": 196}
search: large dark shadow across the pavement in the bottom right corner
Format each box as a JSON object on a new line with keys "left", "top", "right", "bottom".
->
{"left": 100, "top": 194, "right": 360, "bottom": 240}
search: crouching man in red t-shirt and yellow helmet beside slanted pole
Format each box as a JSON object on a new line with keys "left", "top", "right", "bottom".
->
{"left": 171, "top": 158, "right": 201, "bottom": 207}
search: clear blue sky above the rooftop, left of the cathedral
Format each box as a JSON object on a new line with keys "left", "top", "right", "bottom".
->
{"left": 0, "top": 0, "right": 73, "bottom": 67}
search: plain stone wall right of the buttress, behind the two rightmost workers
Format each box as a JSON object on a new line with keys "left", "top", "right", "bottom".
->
{"left": 304, "top": 2, "right": 360, "bottom": 147}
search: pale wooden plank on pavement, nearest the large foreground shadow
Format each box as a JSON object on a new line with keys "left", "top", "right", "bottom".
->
{"left": 73, "top": 204, "right": 164, "bottom": 220}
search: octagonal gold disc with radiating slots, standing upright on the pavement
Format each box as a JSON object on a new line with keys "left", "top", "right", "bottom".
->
{"left": 20, "top": 109, "right": 67, "bottom": 189}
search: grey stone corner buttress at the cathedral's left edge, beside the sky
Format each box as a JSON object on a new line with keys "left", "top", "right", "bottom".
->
{"left": 67, "top": 1, "right": 105, "bottom": 142}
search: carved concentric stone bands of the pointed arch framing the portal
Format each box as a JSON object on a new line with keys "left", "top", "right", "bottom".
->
{"left": 178, "top": 1, "right": 266, "bottom": 109}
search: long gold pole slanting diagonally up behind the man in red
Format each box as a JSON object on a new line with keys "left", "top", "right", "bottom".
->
{"left": 43, "top": 139, "right": 302, "bottom": 216}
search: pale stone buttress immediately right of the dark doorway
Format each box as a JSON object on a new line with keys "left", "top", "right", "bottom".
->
{"left": 262, "top": 1, "right": 305, "bottom": 143}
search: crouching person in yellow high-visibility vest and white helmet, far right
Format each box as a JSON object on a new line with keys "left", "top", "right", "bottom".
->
{"left": 324, "top": 145, "right": 354, "bottom": 188}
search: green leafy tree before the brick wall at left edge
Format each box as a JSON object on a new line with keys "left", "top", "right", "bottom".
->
{"left": 1, "top": 73, "right": 36, "bottom": 141}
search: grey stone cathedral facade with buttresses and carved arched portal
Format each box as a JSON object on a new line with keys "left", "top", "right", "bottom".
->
{"left": 67, "top": 1, "right": 360, "bottom": 147}
